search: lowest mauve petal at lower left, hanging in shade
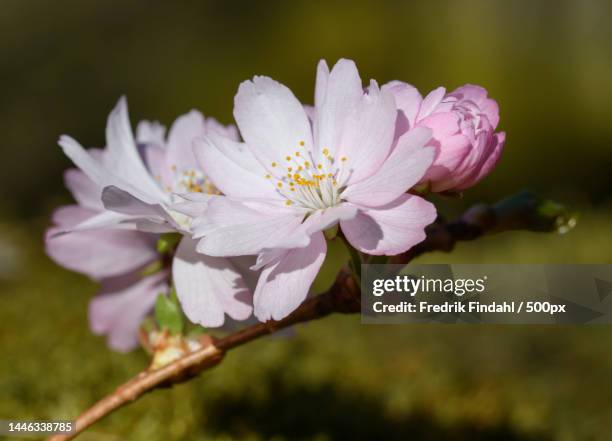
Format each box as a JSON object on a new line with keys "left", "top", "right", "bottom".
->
{"left": 89, "top": 272, "right": 168, "bottom": 352}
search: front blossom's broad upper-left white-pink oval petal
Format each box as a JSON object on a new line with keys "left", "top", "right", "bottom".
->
{"left": 234, "top": 76, "right": 312, "bottom": 168}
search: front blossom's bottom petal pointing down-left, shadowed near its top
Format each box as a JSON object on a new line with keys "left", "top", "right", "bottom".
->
{"left": 254, "top": 233, "right": 327, "bottom": 322}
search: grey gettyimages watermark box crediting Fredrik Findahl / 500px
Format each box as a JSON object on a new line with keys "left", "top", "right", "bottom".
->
{"left": 361, "top": 264, "right": 612, "bottom": 324}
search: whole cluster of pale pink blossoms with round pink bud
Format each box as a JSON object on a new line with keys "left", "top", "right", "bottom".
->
{"left": 46, "top": 59, "right": 505, "bottom": 351}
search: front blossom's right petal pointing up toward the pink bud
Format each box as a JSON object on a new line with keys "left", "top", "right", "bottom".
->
{"left": 342, "top": 127, "right": 435, "bottom": 207}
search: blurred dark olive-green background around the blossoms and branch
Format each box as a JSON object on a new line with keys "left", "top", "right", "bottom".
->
{"left": 0, "top": 0, "right": 612, "bottom": 441}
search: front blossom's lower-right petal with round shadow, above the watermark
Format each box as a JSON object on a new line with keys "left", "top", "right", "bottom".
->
{"left": 340, "top": 194, "right": 436, "bottom": 256}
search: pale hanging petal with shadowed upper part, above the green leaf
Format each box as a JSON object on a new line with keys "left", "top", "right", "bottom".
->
{"left": 172, "top": 238, "right": 253, "bottom": 327}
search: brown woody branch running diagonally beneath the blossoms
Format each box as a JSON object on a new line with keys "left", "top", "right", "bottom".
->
{"left": 48, "top": 193, "right": 567, "bottom": 441}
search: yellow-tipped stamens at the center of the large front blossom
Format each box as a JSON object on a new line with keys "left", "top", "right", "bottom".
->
{"left": 266, "top": 141, "right": 350, "bottom": 212}
